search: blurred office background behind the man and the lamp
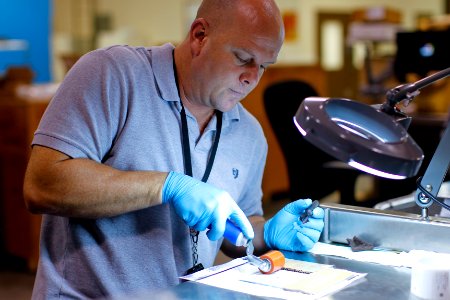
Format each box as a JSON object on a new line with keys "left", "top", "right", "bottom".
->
{"left": 0, "top": 0, "right": 450, "bottom": 298}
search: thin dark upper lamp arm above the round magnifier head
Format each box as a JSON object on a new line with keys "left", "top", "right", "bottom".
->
{"left": 381, "top": 67, "right": 450, "bottom": 115}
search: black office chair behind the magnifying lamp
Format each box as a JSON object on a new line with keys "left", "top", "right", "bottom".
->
{"left": 263, "top": 80, "right": 362, "bottom": 205}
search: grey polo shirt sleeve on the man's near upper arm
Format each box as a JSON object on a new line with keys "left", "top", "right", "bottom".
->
{"left": 33, "top": 50, "right": 127, "bottom": 161}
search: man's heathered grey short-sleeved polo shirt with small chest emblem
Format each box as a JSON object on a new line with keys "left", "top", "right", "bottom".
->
{"left": 33, "top": 44, "right": 267, "bottom": 299}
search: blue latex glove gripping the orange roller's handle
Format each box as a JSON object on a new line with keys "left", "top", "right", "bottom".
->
{"left": 162, "top": 172, "right": 255, "bottom": 241}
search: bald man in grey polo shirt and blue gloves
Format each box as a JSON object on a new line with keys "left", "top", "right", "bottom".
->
{"left": 24, "top": 0, "right": 323, "bottom": 299}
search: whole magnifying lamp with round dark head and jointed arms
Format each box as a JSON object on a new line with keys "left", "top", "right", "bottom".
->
{"left": 294, "top": 68, "right": 450, "bottom": 218}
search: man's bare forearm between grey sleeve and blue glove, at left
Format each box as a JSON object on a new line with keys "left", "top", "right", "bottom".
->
{"left": 24, "top": 146, "right": 167, "bottom": 218}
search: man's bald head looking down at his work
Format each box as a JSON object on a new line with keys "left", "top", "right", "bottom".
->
{"left": 175, "top": 0, "right": 284, "bottom": 116}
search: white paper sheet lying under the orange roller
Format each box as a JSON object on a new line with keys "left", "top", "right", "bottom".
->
{"left": 182, "top": 258, "right": 366, "bottom": 299}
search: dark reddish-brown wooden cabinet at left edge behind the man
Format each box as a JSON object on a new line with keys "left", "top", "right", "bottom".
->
{"left": 0, "top": 97, "right": 48, "bottom": 270}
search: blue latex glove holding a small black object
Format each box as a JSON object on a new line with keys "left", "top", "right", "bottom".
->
{"left": 264, "top": 199, "right": 324, "bottom": 251}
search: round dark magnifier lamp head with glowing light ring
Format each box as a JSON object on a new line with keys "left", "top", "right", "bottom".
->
{"left": 294, "top": 97, "right": 423, "bottom": 179}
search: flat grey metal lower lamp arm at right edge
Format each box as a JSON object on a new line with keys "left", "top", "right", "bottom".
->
{"left": 415, "top": 126, "right": 450, "bottom": 209}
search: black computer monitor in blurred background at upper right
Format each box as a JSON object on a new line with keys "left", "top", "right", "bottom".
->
{"left": 394, "top": 29, "right": 450, "bottom": 82}
